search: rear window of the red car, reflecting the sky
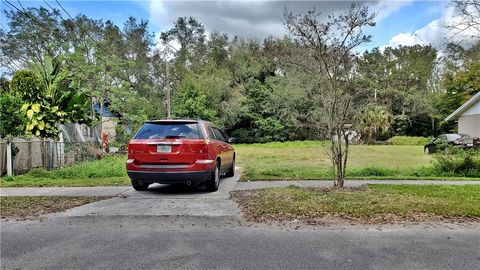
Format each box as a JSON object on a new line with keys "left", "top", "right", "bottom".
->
{"left": 135, "top": 123, "right": 202, "bottom": 139}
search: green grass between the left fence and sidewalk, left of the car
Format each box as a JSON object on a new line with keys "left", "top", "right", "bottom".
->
{"left": 0, "top": 156, "right": 130, "bottom": 187}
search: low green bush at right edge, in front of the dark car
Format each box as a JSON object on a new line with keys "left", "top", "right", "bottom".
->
{"left": 433, "top": 147, "right": 480, "bottom": 177}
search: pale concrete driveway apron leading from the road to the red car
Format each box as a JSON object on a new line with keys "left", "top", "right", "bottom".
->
{"left": 54, "top": 174, "right": 240, "bottom": 218}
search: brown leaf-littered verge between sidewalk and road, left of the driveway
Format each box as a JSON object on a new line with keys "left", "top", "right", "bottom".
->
{"left": 0, "top": 196, "right": 111, "bottom": 220}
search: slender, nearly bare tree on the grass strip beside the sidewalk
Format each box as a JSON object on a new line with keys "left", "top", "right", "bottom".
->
{"left": 284, "top": 4, "right": 375, "bottom": 187}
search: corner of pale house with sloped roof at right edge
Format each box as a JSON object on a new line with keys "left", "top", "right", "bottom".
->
{"left": 445, "top": 92, "right": 480, "bottom": 138}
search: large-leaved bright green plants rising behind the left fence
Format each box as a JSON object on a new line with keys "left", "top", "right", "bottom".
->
{"left": 10, "top": 59, "right": 92, "bottom": 138}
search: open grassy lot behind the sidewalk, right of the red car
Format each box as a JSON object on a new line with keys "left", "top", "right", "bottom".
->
{"left": 235, "top": 141, "right": 479, "bottom": 181}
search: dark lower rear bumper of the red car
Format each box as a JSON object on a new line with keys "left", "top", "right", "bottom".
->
{"left": 127, "top": 170, "right": 212, "bottom": 184}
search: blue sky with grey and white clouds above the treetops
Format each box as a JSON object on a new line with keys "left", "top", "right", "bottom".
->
{"left": 0, "top": 0, "right": 472, "bottom": 50}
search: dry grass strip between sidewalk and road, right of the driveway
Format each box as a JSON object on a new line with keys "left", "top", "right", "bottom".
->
{"left": 234, "top": 185, "right": 480, "bottom": 223}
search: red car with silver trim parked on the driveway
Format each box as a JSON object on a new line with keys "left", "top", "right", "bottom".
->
{"left": 126, "top": 119, "right": 235, "bottom": 191}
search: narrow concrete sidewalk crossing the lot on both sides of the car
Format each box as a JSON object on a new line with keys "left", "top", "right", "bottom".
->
{"left": 0, "top": 180, "right": 480, "bottom": 196}
